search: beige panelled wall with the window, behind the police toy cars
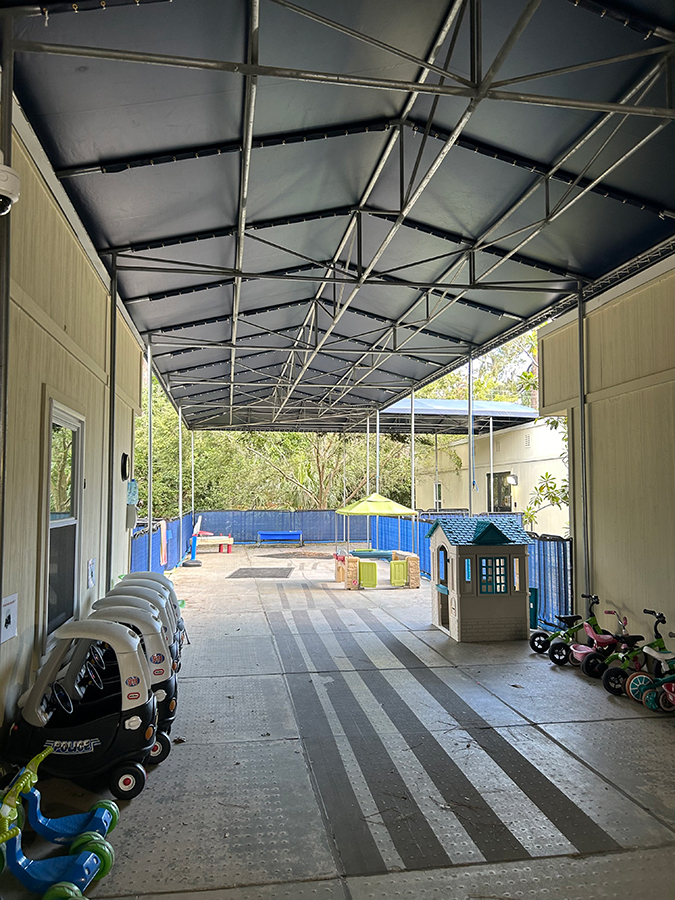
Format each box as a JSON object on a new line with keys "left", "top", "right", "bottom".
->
{"left": 0, "top": 135, "right": 141, "bottom": 717}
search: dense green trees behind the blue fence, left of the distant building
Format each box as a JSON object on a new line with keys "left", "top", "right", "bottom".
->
{"left": 135, "top": 380, "right": 410, "bottom": 518}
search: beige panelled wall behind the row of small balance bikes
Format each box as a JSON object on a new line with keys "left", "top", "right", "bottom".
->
{"left": 539, "top": 259, "right": 675, "bottom": 636}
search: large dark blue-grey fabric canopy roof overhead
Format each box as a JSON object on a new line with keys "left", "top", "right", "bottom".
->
{"left": 9, "top": 0, "right": 675, "bottom": 431}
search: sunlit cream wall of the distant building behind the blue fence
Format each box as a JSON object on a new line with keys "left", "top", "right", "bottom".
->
{"left": 415, "top": 421, "right": 569, "bottom": 535}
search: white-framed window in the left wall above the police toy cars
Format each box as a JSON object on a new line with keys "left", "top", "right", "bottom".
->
{"left": 47, "top": 403, "right": 84, "bottom": 634}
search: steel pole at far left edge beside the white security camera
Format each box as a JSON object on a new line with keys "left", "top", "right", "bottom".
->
{"left": 0, "top": 22, "right": 14, "bottom": 624}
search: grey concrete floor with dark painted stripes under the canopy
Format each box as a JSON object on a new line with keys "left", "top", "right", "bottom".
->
{"left": 0, "top": 546, "right": 675, "bottom": 900}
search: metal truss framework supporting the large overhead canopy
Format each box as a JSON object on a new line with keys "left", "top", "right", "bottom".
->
{"left": 14, "top": 0, "right": 675, "bottom": 429}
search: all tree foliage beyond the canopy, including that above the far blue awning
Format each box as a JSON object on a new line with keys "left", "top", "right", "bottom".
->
{"left": 135, "top": 333, "right": 556, "bottom": 518}
